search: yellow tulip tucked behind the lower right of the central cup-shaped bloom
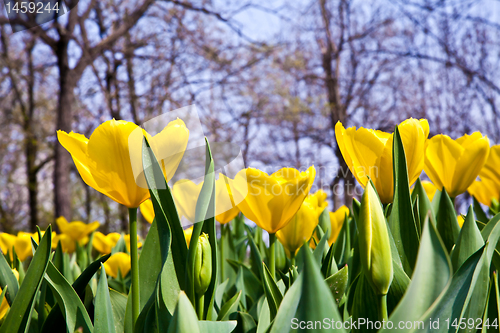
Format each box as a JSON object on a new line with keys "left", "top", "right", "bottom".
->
{"left": 276, "top": 191, "right": 328, "bottom": 258}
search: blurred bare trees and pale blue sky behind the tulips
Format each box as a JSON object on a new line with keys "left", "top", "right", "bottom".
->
{"left": 0, "top": 0, "right": 500, "bottom": 232}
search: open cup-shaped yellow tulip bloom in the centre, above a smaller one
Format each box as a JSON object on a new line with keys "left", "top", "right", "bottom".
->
{"left": 230, "top": 166, "right": 316, "bottom": 234}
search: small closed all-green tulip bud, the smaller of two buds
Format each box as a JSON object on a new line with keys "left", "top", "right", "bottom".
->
{"left": 194, "top": 233, "right": 212, "bottom": 295}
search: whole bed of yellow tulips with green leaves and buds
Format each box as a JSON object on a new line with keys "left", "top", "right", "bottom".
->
{"left": 0, "top": 118, "right": 500, "bottom": 333}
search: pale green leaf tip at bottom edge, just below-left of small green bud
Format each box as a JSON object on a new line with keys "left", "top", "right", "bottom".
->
{"left": 167, "top": 292, "right": 200, "bottom": 333}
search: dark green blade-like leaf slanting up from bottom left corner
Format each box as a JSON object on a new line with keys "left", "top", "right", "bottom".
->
{"left": 0, "top": 226, "right": 52, "bottom": 333}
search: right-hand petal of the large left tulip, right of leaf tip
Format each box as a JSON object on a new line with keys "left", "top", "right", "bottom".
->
{"left": 150, "top": 119, "right": 189, "bottom": 181}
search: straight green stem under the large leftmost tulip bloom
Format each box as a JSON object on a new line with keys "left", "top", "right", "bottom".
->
{"left": 128, "top": 208, "right": 139, "bottom": 327}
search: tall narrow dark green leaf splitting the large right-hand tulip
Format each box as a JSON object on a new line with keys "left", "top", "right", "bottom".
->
{"left": 389, "top": 126, "right": 419, "bottom": 275}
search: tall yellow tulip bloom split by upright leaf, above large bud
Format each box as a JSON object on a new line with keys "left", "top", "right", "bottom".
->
{"left": 335, "top": 118, "right": 429, "bottom": 203}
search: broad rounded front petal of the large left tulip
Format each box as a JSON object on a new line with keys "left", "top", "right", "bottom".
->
{"left": 88, "top": 119, "right": 149, "bottom": 208}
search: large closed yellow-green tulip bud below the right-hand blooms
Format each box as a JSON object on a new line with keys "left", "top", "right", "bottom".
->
{"left": 358, "top": 182, "right": 393, "bottom": 295}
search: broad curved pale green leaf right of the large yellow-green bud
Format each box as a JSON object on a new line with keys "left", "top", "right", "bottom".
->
{"left": 380, "top": 218, "right": 452, "bottom": 332}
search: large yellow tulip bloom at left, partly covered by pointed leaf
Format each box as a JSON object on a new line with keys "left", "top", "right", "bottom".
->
{"left": 57, "top": 119, "right": 189, "bottom": 208}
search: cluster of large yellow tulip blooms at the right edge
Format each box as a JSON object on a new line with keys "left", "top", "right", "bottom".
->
{"left": 335, "top": 118, "right": 494, "bottom": 206}
